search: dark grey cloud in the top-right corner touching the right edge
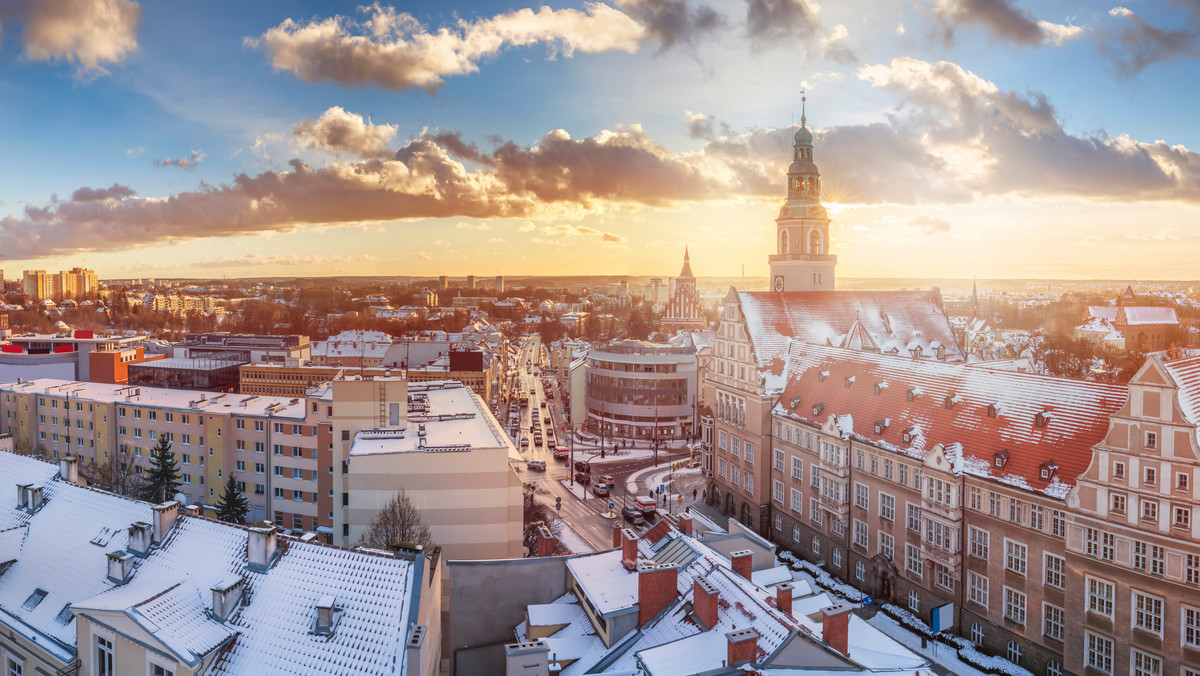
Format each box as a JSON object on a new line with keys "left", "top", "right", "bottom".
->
{"left": 1097, "top": 7, "right": 1198, "bottom": 77}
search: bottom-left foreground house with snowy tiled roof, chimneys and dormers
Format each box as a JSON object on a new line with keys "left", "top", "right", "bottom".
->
{"left": 0, "top": 453, "right": 442, "bottom": 676}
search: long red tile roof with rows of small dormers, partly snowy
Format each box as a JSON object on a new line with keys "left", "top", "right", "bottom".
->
{"left": 775, "top": 345, "right": 1128, "bottom": 499}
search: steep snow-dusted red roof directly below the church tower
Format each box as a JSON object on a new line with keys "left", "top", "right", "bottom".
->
{"left": 738, "top": 291, "right": 965, "bottom": 367}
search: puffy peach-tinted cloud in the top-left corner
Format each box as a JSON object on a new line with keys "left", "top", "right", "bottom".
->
{"left": 17, "top": 0, "right": 142, "bottom": 78}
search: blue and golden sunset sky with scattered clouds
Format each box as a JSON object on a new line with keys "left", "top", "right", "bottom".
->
{"left": 0, "top": 0, "right": 1200, "bottom": 280}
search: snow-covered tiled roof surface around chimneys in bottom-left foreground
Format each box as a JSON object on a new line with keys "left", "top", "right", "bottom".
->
{"left": 0, "top": 453, "right": 415, "bottom": 676}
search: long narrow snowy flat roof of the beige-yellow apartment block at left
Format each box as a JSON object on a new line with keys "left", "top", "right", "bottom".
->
{"left": 0, "top": 379, "right": 305, "bottom": 419}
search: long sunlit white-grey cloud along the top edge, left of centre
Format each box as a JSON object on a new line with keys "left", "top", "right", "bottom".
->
{"left": 246, "top": 2, "right": 648, "bottom": 92}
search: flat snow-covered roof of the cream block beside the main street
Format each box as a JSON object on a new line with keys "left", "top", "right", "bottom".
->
{"left": 350, "top": 381, "right": 511, "bottom": 456}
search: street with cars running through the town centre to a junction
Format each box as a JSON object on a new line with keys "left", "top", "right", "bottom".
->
{"left": 502, "top": 336, "right": 688, "bottom": 549}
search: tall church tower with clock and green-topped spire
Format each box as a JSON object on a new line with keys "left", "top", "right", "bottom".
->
{"left": 769, "top": 97, "right": 838, "bottom": 291}
